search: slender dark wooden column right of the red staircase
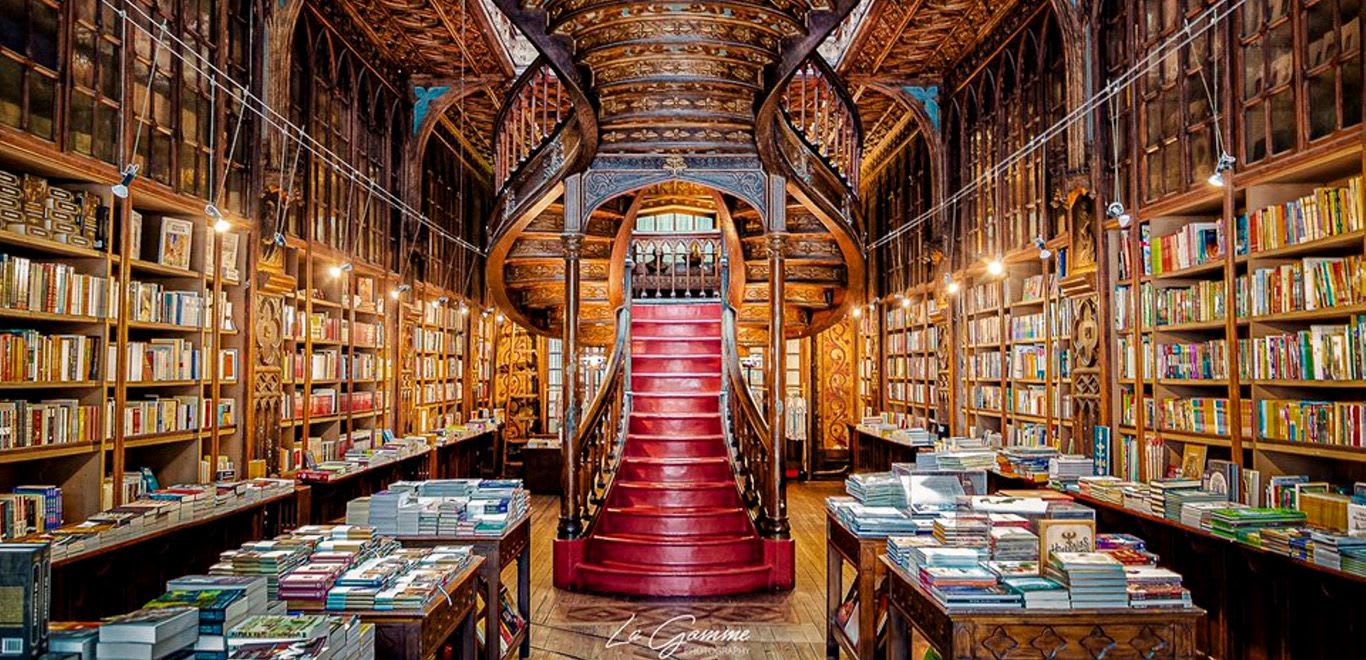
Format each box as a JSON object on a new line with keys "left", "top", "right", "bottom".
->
{"left": 762, "top": 231, "right": 788, "bottom": 538}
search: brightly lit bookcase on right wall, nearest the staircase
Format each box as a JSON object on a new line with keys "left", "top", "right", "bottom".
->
{"left": 882, "top": 286, "right": 940, "bottom": 428}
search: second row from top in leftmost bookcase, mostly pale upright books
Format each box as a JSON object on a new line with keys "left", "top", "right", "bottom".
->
{"left": 0, "top": 254, "right": 111, "bottom": 318}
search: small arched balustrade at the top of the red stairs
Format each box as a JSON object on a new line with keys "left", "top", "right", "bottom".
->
{"left": 631, "top": 232, "right": 721, "bottom": 299}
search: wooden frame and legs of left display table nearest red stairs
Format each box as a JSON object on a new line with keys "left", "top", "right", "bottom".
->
{"left": 396, "top": 512, "right": 531, "bottom": 660}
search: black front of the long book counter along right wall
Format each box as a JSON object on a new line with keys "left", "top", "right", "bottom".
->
{"left": 1067, "top": 492, "right": 1366, "bottom": 659}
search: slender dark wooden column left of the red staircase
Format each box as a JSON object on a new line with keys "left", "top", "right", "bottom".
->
{"left": 559, "top": 232, "right": 585, "bottom": 538}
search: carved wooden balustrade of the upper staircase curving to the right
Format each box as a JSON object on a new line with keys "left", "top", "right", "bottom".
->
{"left": 781, "top": 52, "right": 863, "bottom": 191}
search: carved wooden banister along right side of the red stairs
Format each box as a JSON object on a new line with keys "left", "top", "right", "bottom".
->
{"left": 721, "top": 258, "right": 785, "bottom": 537}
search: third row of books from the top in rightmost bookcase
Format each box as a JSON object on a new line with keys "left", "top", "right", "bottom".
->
{"left": 1238, "top": 316, "right": 1366, "bottom": 380}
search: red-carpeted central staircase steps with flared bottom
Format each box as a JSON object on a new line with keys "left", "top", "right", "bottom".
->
{"left": 555, "top": 303, "right": 795, "bottom": 596}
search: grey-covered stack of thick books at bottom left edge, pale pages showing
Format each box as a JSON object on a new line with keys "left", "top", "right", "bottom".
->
{"left": 96, "top": 607, "right": 199, "bottom": 660}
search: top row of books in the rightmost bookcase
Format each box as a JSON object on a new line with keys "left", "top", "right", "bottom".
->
{"left": 1235, "top": 176, "right": 1366, "bottom": 254}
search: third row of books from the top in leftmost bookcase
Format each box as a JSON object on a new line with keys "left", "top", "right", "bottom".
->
{"left": 0, "top": 329, "right": 104, "bottom": 383}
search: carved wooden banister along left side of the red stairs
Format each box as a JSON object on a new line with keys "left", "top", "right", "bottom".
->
{"left": 560, "top": 268, "right": 631, "bottom": 538}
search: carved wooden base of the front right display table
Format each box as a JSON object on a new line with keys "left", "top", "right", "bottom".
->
{"left": 880, "top": 558, "right": 1205, "bottom": 660}
